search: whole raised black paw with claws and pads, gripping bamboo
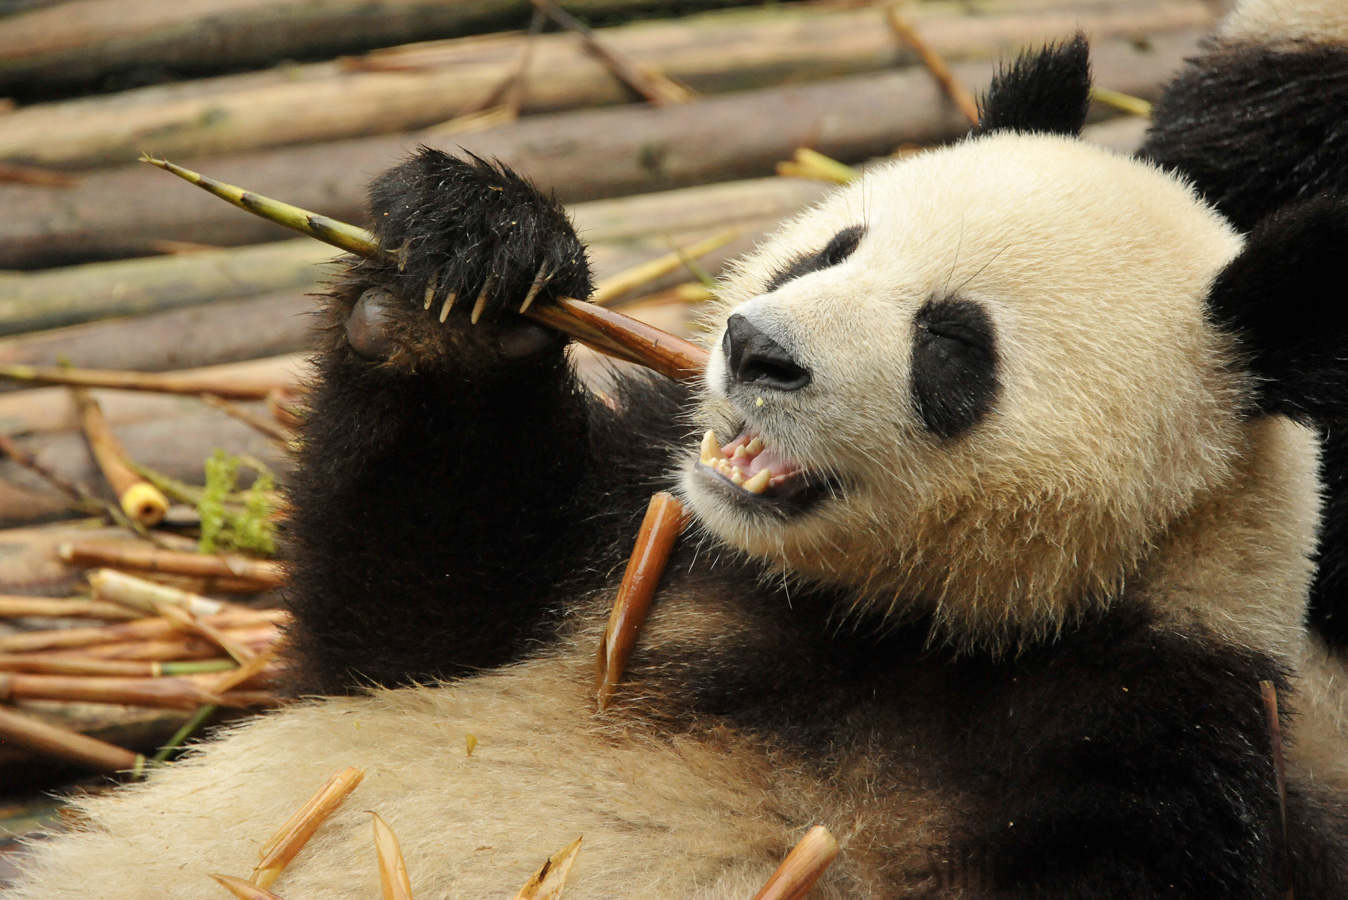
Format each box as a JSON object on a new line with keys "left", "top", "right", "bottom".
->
{"left": 345, "top": 148, "right": 592, "bottom": 361}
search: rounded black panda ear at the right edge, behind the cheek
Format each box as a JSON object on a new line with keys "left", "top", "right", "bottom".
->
{"left": 1208, "top": 195, "right": 1348, "bottom": 423}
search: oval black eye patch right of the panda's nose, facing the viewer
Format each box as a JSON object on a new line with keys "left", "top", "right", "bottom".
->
{"left": 913, "top": 299, "right": 998, "bottom": 438}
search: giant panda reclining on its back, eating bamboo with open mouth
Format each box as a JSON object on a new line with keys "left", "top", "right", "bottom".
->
{"left": 7, "top": 7, "right": 1348, "bottom": 900}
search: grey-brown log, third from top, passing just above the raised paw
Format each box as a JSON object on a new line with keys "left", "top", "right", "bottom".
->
{"left": 0, "top": 30, "right": 1201, "bottom": 266}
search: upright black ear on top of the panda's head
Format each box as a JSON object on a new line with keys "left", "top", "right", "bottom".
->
{"left": 979, "top": 31, "right": 1091, "bottom": 137}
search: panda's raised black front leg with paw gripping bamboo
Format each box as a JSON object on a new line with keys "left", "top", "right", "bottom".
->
{"left": 288, "top": 150, "right": 592, "bottom": 693}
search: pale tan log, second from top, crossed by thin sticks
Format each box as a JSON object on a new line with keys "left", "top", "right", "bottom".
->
{"left": 0, "top": 0, "right": 1212, "bottom": 168}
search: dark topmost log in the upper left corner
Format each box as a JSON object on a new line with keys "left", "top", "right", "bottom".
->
{"left": 0, "top": 0, "right": 754, "bottom": 97}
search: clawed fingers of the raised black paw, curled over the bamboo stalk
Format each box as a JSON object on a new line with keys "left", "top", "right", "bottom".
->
{"left": 369, "top": 148, "right": 590, "bottom": 325}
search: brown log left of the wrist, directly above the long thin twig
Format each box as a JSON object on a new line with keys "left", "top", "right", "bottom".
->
{"left": 0, "top": 288, "right": 314, "bottom": 379}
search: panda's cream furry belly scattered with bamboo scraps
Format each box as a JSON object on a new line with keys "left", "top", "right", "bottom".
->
{"left": 10, "top": 653, "right": 959, "bottom": 900}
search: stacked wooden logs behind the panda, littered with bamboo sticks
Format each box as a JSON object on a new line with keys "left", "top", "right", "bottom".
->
{"left": 0, "top": 0, "right": 1219, "bottom": 880}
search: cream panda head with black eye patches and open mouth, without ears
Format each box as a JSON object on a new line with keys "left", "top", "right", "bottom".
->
{"left": 682, "top": 133, "right": 1247, "bottom": 641}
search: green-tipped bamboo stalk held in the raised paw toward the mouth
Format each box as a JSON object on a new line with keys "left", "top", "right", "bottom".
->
{"left": 144, "top": 156, "right": 708, "bottom": 381}
